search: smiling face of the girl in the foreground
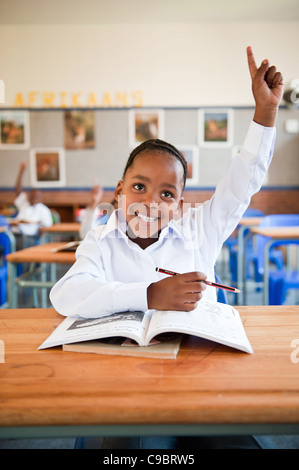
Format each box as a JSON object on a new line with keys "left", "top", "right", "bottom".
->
{"left": 115, "top": 151, "right": 184, "bottom": 248}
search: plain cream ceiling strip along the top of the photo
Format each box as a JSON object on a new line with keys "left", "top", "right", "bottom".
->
{"left": 0, "top": 0, "right": 299, "bottom": 24}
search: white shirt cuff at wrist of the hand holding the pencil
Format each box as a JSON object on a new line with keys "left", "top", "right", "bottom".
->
{"left": 113, "top": 282, "right": 151, "bottom": 312}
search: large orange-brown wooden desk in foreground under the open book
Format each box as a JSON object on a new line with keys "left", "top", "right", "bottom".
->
{"left": 0, "top": 306, "right": 299, "bottom": 438}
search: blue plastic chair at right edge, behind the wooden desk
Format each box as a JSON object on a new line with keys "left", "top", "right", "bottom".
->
{"left": 256, "top": 214, "right": 299, "bottom": 305}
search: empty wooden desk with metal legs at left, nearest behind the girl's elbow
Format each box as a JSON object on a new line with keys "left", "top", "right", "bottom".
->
{"left": 6, "top": 242, "right": 75, "bottom": 308}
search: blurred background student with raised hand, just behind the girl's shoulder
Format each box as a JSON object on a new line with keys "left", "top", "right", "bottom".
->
{"left": 80, "top": 184, "right": 116, "bottom": 240}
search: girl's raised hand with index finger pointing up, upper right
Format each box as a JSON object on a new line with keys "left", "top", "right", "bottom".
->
{"left": 247, "top": 46, "right": 283, "bottom": 127}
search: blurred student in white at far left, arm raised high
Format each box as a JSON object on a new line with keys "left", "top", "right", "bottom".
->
{"left": 13, "top": 162, "right": 53, "bottom": 249}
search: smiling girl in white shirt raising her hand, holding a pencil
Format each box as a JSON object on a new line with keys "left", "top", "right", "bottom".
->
{"left": 50, "top": 47, "right": 283, "bottom": 318}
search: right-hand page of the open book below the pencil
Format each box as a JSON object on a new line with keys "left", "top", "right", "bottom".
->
{"left": 146, "top": 300, "right": 253, "bottom": 353}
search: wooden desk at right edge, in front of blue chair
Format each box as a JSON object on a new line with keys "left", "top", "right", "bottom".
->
{"left": 250, "top": 226, "right": 299, "bottom": 305}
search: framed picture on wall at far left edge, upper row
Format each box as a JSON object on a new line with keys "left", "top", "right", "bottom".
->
{"left": 0, "top": 111, "right": 30, "bottom": 150}
